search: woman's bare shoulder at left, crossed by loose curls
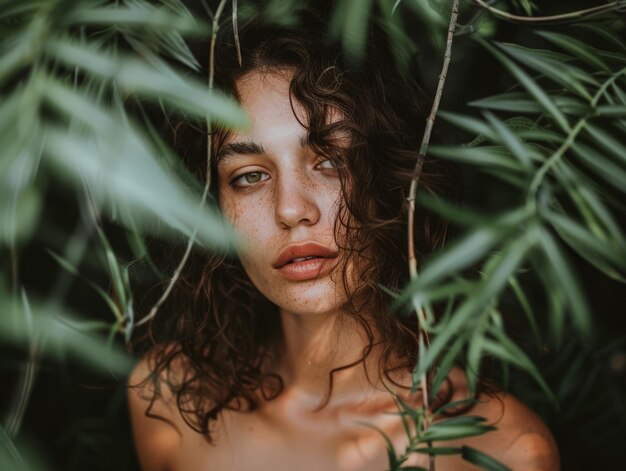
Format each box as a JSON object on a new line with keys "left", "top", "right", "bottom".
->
{"left": 128, "top": 346, "right": 182, "bottom": 471}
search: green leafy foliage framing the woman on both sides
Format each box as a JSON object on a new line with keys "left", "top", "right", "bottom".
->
{"left": 0, "top": 0, "right": 626, "bottom": 469}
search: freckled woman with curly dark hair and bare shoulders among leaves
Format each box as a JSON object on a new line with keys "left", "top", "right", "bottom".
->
{"left": 129, "top": 11, "right": 558, "bottom": 470}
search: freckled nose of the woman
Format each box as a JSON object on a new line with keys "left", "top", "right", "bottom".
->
{"left": 275, "top": 175, "right": 320, "bottom": 228}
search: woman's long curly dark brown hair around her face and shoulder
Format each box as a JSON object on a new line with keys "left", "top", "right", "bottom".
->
{"left": 132, "top": 6, "right": 454, "bottom": 440}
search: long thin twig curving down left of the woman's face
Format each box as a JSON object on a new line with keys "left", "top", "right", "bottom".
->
{"left": 135, "top": 0, "right": 228, "bottom": 327}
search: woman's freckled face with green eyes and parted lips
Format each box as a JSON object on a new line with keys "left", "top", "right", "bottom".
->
{"left": 217, "top": 72, "right": 346, "bottom": 314}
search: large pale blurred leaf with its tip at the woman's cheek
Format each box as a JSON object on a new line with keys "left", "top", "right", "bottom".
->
{"left": 46, "top": 123, "right": 238, "bottom": 248}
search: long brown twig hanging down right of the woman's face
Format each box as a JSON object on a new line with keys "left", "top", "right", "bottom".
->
{"left": 407, "top": 0, "right": 459, "bottom": 470}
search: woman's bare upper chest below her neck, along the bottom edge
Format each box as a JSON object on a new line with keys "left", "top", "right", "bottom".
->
{"left": 168, "top": 406, "right": 427, "bottom": 471}
